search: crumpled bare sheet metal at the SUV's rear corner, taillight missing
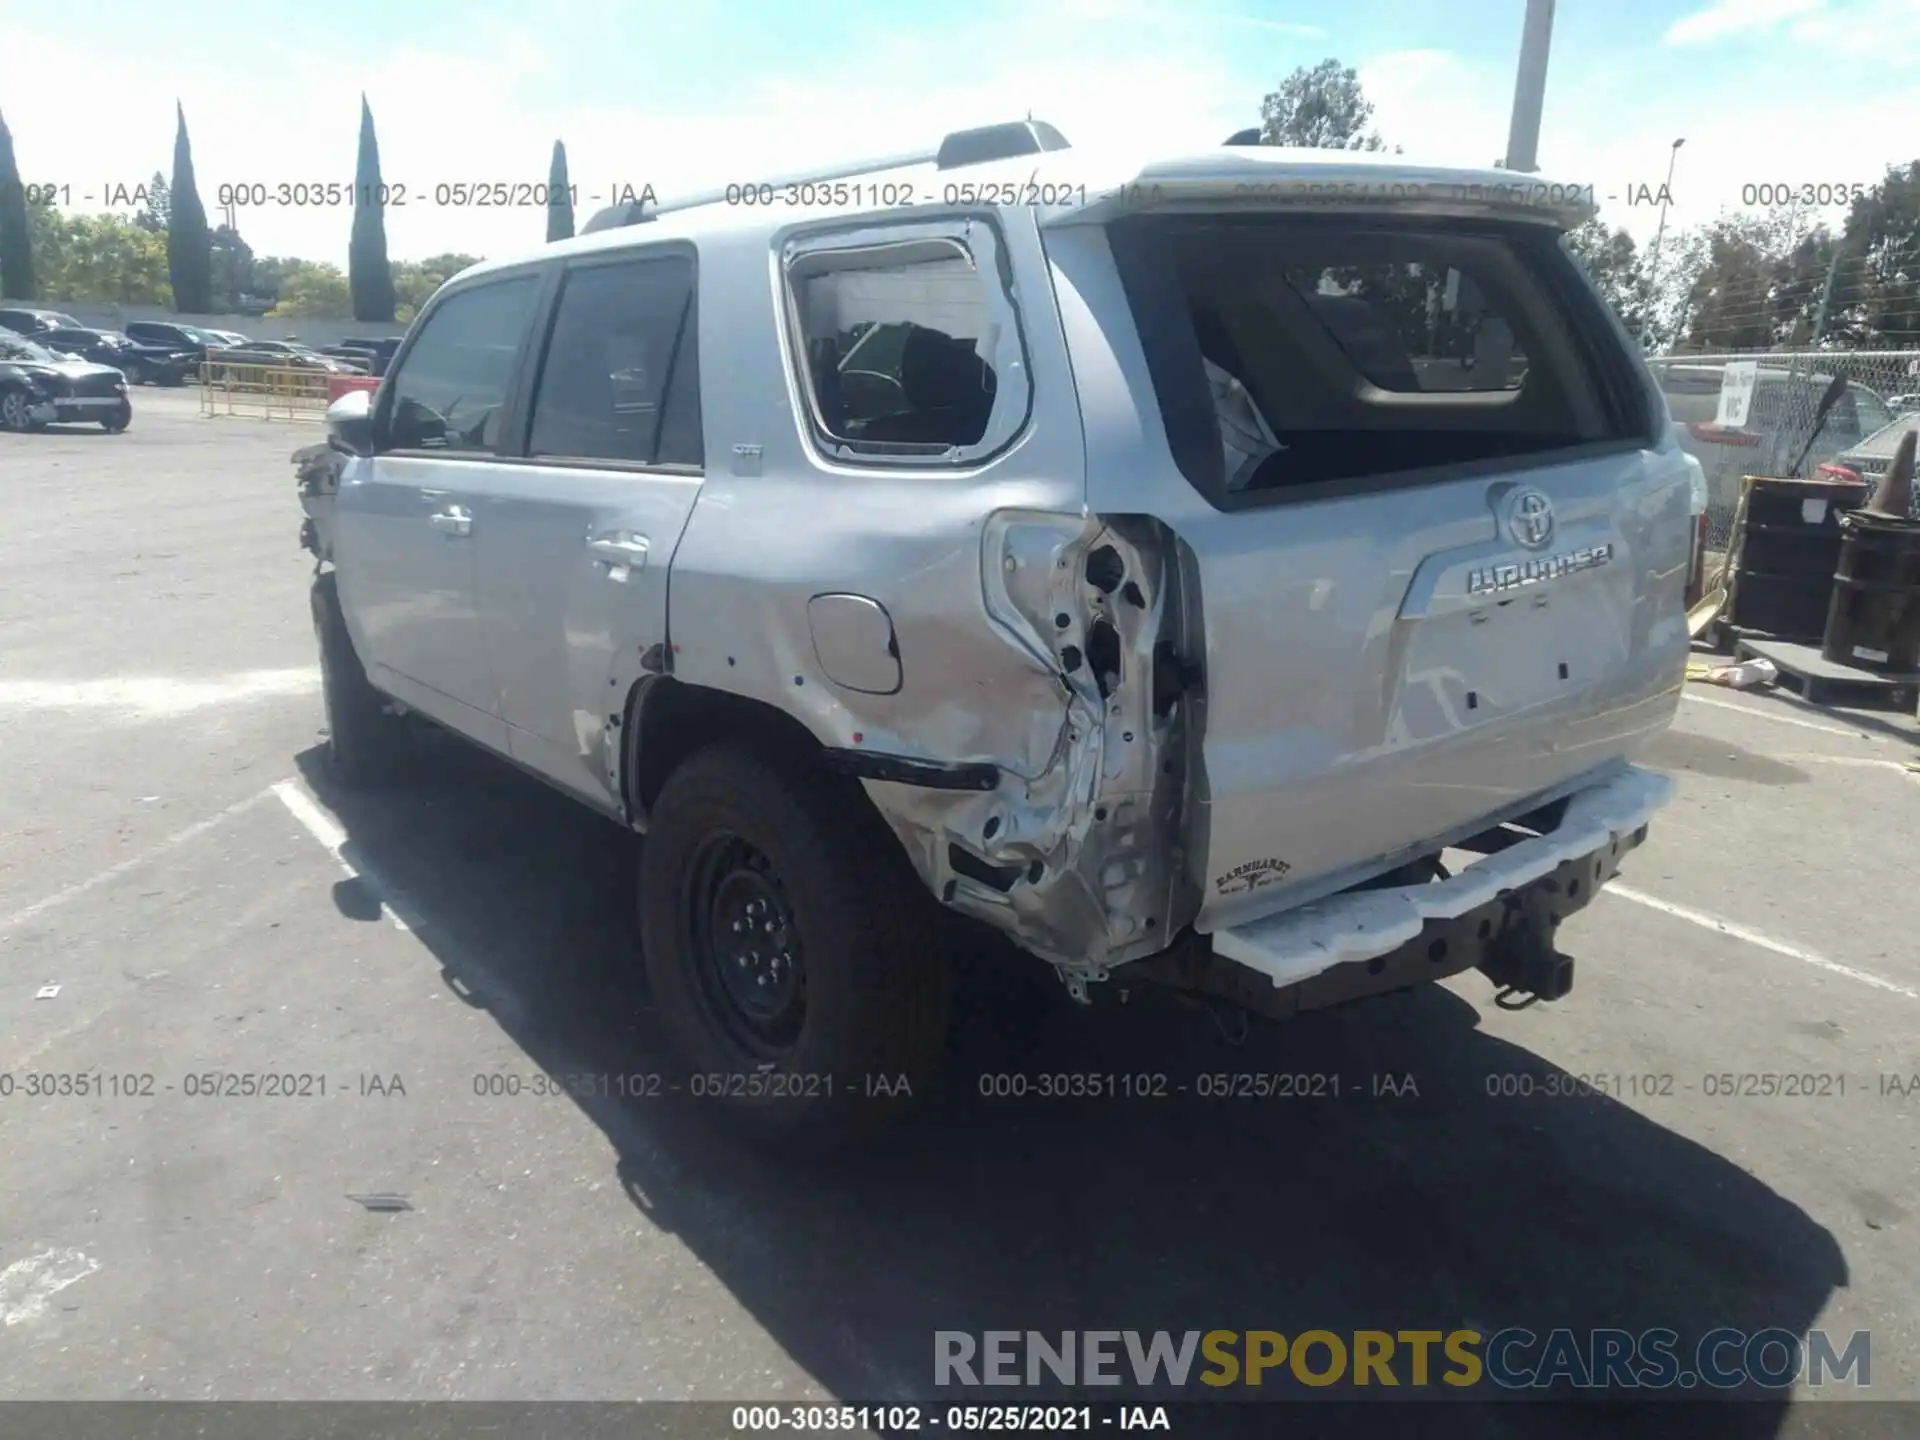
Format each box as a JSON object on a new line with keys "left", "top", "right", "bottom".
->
{"left": 866, "top": 511, "right": 1198, "bottom": 981}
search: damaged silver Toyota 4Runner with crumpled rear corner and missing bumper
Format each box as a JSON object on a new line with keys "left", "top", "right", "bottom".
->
{"left": 300, "top": 123, "right": 1690, "bottom": 1131}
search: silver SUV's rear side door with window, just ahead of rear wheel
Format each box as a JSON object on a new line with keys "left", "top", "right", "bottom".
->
{"left": 476, "top": 246, "right": 703, "bottom": 812}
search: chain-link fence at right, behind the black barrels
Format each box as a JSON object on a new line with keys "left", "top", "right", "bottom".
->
{"left": 1647, "top": 349, "right": 1920, "bottom": 570}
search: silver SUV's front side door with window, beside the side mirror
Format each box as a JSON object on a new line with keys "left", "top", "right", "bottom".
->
{"left": 334, "top": 273, "right": 538, "bottom": 751}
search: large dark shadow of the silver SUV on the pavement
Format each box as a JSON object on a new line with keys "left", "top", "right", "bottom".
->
{"left": 300, "top": 737, "right": 1847, "bottom": 1436}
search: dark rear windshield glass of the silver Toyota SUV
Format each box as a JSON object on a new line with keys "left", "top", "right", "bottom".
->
{"left": 1110, "top": 215, "right": 1647, "bottom": 501}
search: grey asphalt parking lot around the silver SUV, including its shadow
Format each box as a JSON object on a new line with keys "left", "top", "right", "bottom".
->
{"left": 0, "top": 390, "right": 1920, "bottom": 1436}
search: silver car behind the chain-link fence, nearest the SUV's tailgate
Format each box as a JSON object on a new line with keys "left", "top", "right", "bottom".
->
{"left": 1651, "top": 361, "right": 1893, "bottom": 522}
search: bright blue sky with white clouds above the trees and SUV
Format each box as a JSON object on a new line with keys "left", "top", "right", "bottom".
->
{"left": 0, "top": 0, "right": 1920, "bottom": 261}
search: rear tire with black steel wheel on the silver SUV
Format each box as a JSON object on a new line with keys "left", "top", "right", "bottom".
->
{"left": 639, "top": 743, "right": 950, "bottom": 1146}
